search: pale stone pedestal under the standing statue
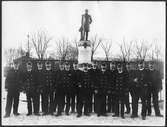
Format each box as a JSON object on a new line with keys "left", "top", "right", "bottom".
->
{"left": 78, "top": 41, "right": 91, "bottom": 64}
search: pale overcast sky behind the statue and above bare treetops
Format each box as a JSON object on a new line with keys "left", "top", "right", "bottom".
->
{"left": 2, "top": 1, "right": 166, "bottom": 56}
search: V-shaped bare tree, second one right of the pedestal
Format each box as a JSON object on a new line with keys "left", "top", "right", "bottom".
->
{"left": 101, "top": 41, "right": 112, "bottom": 61}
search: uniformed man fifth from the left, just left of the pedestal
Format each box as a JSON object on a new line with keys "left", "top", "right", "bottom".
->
{"left": 56, "top": 62, "right": 65, "bottom": 116}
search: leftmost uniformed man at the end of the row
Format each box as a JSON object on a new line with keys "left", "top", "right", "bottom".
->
{"left": 4, "top": 63, "right": 21, "bottom": 118}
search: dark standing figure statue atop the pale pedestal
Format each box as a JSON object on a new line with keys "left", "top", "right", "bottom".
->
{"left": 79, "top": 9, "right": 92, "bottom": 41}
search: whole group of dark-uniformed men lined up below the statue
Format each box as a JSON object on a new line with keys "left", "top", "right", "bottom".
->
{"left": 4, "top": 61, "right": 163, "bottom": 120}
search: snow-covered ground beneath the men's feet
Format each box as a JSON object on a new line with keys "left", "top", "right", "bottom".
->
{"left": 1, "top": 92, "right": 164, "bottom": 126}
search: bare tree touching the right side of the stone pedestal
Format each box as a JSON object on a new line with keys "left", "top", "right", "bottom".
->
{"left": 91, "top": 34, "right": 102, "bottom": 61}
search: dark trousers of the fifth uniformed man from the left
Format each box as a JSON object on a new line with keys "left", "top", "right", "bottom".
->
{"left": 56, "top": 88, "right": 65, "bottom": 114}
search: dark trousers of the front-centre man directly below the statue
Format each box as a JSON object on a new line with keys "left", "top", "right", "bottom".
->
{"left": 77, "top": 89, "right": 90, "bottom": 115}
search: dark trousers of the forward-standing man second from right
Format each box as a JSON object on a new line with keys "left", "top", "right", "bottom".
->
{"left": 131, "top": 87, "right": 148, "bottom": 116}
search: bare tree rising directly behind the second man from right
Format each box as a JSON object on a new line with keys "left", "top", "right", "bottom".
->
{"left": 133, "top": 39, "right": 152, "bottom": 61}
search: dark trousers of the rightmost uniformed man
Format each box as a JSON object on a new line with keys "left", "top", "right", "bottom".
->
{"left": 147, "top": 87, "right": 160, "bottom": 115}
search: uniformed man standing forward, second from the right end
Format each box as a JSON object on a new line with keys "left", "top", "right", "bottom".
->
{"left": 131, "top": 62, "right": 148, "bottom": 120}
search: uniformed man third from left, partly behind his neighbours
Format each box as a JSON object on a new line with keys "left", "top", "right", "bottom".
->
{"left": 36, "top": 61, "right": 44, "bottom": 113}
